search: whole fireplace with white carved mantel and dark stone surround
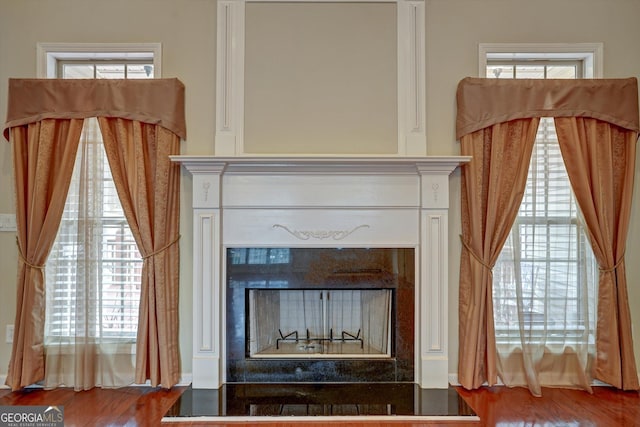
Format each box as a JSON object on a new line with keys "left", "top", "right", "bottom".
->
{"left": 172, "top": 156, "right": 469, "bottom": 388}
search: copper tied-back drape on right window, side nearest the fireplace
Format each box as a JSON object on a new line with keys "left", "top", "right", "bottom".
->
{"left": 458, "top": 118, "right": 539, "bottom": 389}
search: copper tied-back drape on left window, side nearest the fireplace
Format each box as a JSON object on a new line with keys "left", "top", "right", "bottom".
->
{"left": 98, "top": 117, "right": 181, "bottom": 388}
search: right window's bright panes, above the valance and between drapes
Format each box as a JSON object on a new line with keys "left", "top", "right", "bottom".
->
{"left": 486, "top": 50, "right": 598, "bottom": 344}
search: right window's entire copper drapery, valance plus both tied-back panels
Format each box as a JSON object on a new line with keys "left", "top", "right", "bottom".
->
{"left": 456, "top": 78, "right": 640, "bottom": 395}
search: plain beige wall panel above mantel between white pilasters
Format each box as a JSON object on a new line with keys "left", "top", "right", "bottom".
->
{"left": 244, "top": 3, "right": 398, "bottom": 154}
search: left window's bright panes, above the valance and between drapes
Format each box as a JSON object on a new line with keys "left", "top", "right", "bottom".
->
{"left": 45, "top": 46, "right": 155, "bottom": 343}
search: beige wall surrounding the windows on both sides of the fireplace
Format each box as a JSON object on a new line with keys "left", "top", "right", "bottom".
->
{"left": 0, "top": 0, "right": 640, "bottom": 386}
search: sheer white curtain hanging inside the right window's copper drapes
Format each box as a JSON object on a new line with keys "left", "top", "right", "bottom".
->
{"left": 493, "top": 119, "right": 598, "bottom": 394}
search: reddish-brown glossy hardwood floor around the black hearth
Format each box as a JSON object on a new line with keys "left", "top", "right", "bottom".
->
{"left": 0, "top": 387, "right": 640, "bottom": 427}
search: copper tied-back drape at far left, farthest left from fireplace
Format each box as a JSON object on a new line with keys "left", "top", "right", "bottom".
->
{"left": 6, "top": 119, "right": 83, "bottom": 390}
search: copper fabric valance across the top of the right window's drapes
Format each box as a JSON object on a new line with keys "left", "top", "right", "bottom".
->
{"left": 456, "top": 77, "right": 640, "bottom": 139}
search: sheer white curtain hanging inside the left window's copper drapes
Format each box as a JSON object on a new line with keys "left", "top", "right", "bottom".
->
{"left": 44, "top": 119, "right": 141, "bottom": 390}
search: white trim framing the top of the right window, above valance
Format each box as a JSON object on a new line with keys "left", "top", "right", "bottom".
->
{"left": 478, "top": 43, "right": 604, "bottom": 79}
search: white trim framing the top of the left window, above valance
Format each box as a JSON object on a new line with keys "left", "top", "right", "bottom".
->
{"left": 36, "top": 42, "right": 162, "bottom": 79}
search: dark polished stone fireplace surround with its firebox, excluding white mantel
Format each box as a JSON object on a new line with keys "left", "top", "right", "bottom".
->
{"left": 226, "top": 248, "right": 415, "bottom": 383}
